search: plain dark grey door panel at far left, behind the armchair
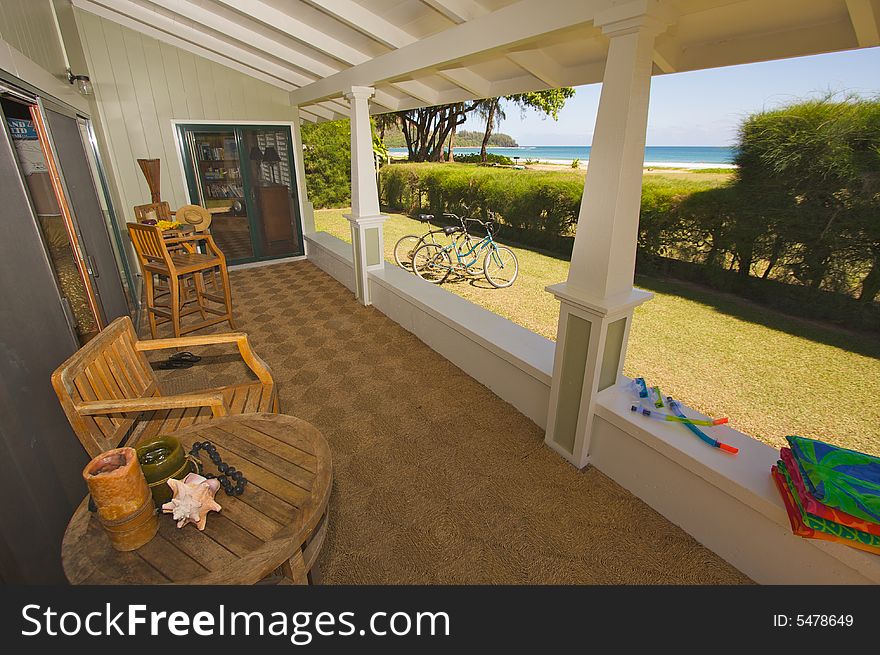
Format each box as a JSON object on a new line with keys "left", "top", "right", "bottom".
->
{"left": 0, "top": 95, "right": 87, "bottom": 583}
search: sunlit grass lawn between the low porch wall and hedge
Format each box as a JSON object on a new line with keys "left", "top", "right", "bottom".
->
{"left": 315, "top": 209, "right": 880, "bottom": 455}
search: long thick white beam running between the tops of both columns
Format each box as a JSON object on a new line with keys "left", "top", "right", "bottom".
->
{"left": 290, "top": 0, "right": 611, "bottom": 105}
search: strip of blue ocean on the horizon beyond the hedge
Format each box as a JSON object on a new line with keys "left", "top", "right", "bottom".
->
{"left": 389, "top": 146, "right": 735, "bottom": 168}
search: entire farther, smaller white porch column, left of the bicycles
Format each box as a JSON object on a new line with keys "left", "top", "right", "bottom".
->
{"left": 345, "top": 86, "right": 388, "bottom": 305}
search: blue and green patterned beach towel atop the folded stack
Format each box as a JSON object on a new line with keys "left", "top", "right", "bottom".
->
{"left": 786, "top": 437, "right": 880, "bottom": 523}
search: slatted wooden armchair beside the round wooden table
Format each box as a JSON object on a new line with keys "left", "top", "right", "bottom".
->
{"left": 52, "top": 316, "right": 279, "bottom": 457}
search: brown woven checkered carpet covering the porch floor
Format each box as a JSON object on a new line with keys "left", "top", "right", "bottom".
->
{"left": 151, "top": 261, "right": 749, "bottom": 584}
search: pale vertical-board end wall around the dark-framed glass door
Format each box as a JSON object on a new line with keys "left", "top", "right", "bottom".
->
{"left": 76, "top": 10, "right": 295, "bottom": 222}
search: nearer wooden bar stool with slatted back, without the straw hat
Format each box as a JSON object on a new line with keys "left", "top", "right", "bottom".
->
{"left": 127, "top": 223, "right": 235, "bottom": 339}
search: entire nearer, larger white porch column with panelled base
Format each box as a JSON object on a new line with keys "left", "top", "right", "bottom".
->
{"left": 545, "top": 0, "right": 668, "bottom": 468}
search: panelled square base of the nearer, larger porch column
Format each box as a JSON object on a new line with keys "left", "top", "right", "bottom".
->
{"left": 544, "top": 283, "right": 654, "bottom": 468}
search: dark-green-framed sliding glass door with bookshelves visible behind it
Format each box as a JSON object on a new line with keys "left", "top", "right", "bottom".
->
{"left": 178, "top": 125, "right": 304, "bottom": 264}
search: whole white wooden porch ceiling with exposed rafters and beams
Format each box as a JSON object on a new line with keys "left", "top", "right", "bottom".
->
{"left": 72, "top": 0, "right": 880, "bottom": 121}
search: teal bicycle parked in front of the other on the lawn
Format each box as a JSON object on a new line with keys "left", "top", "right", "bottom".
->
{"left": 412, "top": 214, "right": 519, "bottom": 289}
